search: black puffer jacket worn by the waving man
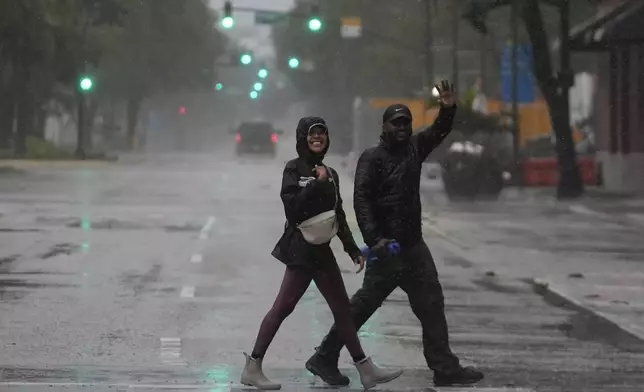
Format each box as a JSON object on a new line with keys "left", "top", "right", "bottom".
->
{"left": 353, "top": 106, "right": 456, "bottom": 247}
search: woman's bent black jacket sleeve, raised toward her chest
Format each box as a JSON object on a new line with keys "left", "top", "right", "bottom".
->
{"left": 280, "top": 163, "right": 333, "bottom": 226}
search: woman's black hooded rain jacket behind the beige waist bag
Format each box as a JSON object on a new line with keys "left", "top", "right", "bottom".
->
{"left": 272, "top": 117, "right": 360, "bottom": 267}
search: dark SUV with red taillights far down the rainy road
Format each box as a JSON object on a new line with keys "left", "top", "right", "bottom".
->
{"left": 235, "top": 121, "right": 282, "bottom": 157}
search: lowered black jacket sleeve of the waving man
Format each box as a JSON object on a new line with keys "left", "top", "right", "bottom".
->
{"left": 353, "top": 150, "right": 382, "bottom": 248}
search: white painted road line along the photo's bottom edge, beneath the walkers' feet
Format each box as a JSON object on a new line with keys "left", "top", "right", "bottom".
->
{"left": 0, "top": 381, "right": 535, "bottom": 392}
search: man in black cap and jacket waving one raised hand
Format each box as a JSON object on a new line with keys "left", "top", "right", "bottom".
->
{"left": 306, "top": 81, "right": 483, "bottom": 386}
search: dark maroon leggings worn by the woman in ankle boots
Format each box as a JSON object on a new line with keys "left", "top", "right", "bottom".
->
{"left": 252, "top": 262, "right": 365, "bottom": 361}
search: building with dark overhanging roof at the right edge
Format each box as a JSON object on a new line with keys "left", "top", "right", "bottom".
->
{"left": 570, "top": 0, "right": 644, "bottom": 194}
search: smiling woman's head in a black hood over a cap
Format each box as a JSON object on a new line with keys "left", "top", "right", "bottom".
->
{"left": 295, "top": 116, "right": 331, "bottom": 164}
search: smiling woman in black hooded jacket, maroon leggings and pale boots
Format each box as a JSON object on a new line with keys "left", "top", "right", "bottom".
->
{"left": 241, "top": 117, "right": 402, "bottom": 389}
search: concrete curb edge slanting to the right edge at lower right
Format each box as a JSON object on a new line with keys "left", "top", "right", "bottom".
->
{"left": 531, "top": 278, "right": 644, "bottom": 351}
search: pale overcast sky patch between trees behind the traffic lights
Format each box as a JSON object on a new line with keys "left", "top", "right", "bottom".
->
{"left": 210, "top": 0, "right": 295, "bottom": 57}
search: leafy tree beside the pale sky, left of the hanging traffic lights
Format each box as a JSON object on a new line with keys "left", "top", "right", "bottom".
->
{"left": 98, "top": 0, "right": 225, "bottom": 147}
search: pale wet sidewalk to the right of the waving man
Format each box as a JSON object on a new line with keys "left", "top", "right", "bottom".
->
{"left": 425, "top": 199, "right": 644, "bottom": 349}
